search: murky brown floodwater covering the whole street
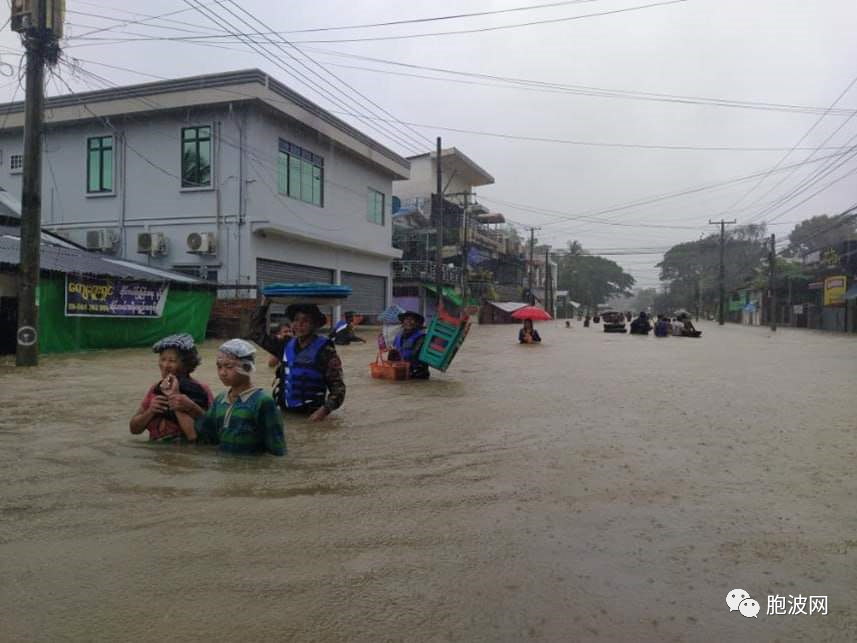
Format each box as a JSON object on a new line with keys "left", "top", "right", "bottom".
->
{"left": 0, "top": 323, "right": 857, "bottom": 641}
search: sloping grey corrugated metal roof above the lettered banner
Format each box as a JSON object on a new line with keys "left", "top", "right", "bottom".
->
{"left": 0, "top": 228, "right": 206, "bottom": 286}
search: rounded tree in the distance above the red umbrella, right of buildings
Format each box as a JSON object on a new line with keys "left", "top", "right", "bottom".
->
{"left": 557, "top": 241, "right": 634, "bottom": 308}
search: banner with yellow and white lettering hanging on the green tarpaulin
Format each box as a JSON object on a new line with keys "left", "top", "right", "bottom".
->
{"left": 65, "top": 275, "right": 169, "bottom": 317}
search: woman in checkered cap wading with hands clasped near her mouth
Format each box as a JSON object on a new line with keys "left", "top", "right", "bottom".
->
{"left": 129, "top": 334, "right": 213, "bottom": 442}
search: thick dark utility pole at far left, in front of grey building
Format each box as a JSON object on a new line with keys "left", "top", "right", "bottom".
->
{"left": 9, "top": 0, "right": 63, "bottom": 366}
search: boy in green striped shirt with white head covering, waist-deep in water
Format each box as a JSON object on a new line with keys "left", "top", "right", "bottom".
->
{"left": 196, "top": 339, "right": 286, "bottom": 456}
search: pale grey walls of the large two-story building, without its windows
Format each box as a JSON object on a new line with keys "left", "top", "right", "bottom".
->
{"left": 0, "top": 103, "right": 399, "bottom": 300}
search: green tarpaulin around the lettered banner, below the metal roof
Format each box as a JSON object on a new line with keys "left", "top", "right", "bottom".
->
{"left": 39, "top": 276, "right": 215, "bottom": 353}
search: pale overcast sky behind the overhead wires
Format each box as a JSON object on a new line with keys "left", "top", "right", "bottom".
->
{"left": 0, "top": 0, "right": 857, "bottom": 287}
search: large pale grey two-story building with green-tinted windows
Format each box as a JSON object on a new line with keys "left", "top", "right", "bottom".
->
{"left": 0, "top": 70, "right": 410, "bottom": 314}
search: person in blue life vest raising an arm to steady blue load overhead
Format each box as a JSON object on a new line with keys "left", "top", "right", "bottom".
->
{"left": 248, "top": 299, "right": 345, "bottom": 422}
